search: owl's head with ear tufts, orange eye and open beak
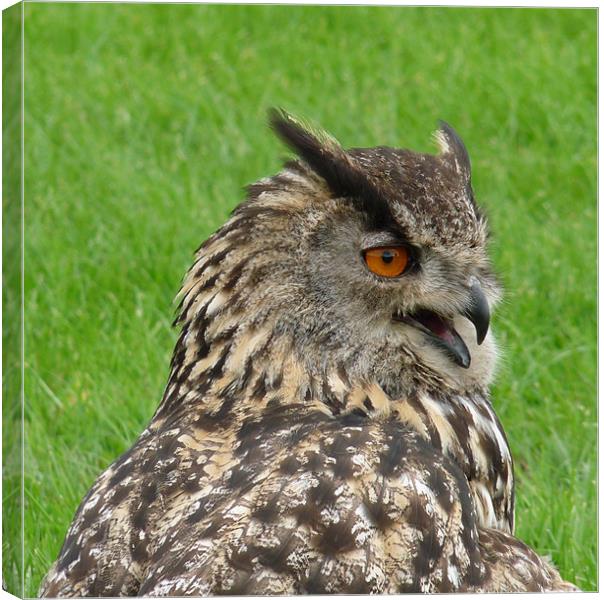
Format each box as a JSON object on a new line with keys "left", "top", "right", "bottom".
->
{"left": 180, "top": 110, "right": 499, "bottom": 406}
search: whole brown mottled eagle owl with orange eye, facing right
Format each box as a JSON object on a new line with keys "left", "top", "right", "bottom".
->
{"left": 40, "top": 110, "right": 575, "bottom": 596}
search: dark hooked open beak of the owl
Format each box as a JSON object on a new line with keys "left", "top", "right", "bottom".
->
{"left": 394, "top": 279, "right": 490, "bottom": 369}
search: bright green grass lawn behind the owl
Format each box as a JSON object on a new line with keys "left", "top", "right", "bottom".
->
{"left": 3, "top": 4, "right": 597, "bottom": 596}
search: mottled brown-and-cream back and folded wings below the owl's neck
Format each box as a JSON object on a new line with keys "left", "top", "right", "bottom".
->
{"left": 41, "top": 405, "right": 576, "bottom": 596}
